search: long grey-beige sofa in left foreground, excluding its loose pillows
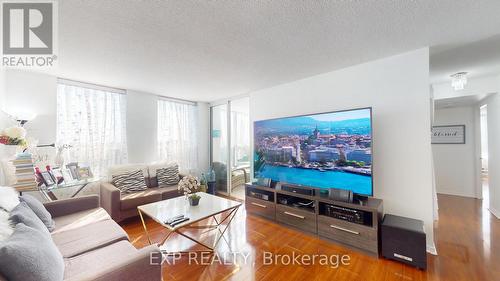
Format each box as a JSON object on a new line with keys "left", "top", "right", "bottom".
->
{"left": 0, "top": 195, "right": 162, "bottom": 281}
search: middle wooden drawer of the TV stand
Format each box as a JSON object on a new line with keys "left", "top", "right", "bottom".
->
{"left": 276, "top": 204, "right": 317, "bottom": 233}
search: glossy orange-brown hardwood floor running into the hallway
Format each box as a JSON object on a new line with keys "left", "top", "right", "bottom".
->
{"left": 122, "top": 195, "right": 500, "bottom": 281}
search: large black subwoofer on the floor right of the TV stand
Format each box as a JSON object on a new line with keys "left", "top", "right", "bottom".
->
{"left": 381, "top": 214, "right": 427, "bottom": 270}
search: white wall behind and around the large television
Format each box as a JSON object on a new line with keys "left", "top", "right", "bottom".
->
{"left": 250, "top": 48, "right": 434, "bottom": 250}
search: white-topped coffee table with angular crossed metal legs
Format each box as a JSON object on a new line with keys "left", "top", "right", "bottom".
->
{"left": 137, "top": 192, "right": 241, "bottom": 254}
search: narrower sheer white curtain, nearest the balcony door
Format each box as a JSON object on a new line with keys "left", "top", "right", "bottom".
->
{"left": 158, "top": 99, "right": 198, "bottom": 173}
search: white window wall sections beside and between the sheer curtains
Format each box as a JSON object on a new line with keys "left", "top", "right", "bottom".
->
{"left": 0, "top": 70, "right": 210, "bottom": 171}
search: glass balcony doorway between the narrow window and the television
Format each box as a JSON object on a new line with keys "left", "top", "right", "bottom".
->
{"left": 210, "top": 97, "right": 251, "bottom": 200}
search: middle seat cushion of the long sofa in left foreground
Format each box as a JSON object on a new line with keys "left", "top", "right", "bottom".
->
{"left": 52, "top": 220, "right": 128, "bottom": 258}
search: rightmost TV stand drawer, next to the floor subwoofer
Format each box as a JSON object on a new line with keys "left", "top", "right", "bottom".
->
{"left": 318, "top": 216, "right": 378, "bottom": 253}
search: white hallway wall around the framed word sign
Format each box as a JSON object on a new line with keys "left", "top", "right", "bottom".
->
{"left": 432, "top": 106, "right": 478, "bottom": 197}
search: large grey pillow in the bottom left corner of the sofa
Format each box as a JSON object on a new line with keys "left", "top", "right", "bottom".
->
{"left": 0, "top": 223, "right": 64, "bottom": 281}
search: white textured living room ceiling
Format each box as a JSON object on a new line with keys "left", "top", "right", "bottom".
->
{"left": 51, "top": 0, "right": 500, "bottom": 101}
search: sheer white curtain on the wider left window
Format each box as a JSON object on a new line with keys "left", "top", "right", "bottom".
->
{"left": 57, "top": 82, "right": 127, "bottom": 176}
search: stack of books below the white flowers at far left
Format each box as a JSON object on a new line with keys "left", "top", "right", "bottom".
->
{"left": 12, "top": 153, "right": 38, "bottom": 192}
